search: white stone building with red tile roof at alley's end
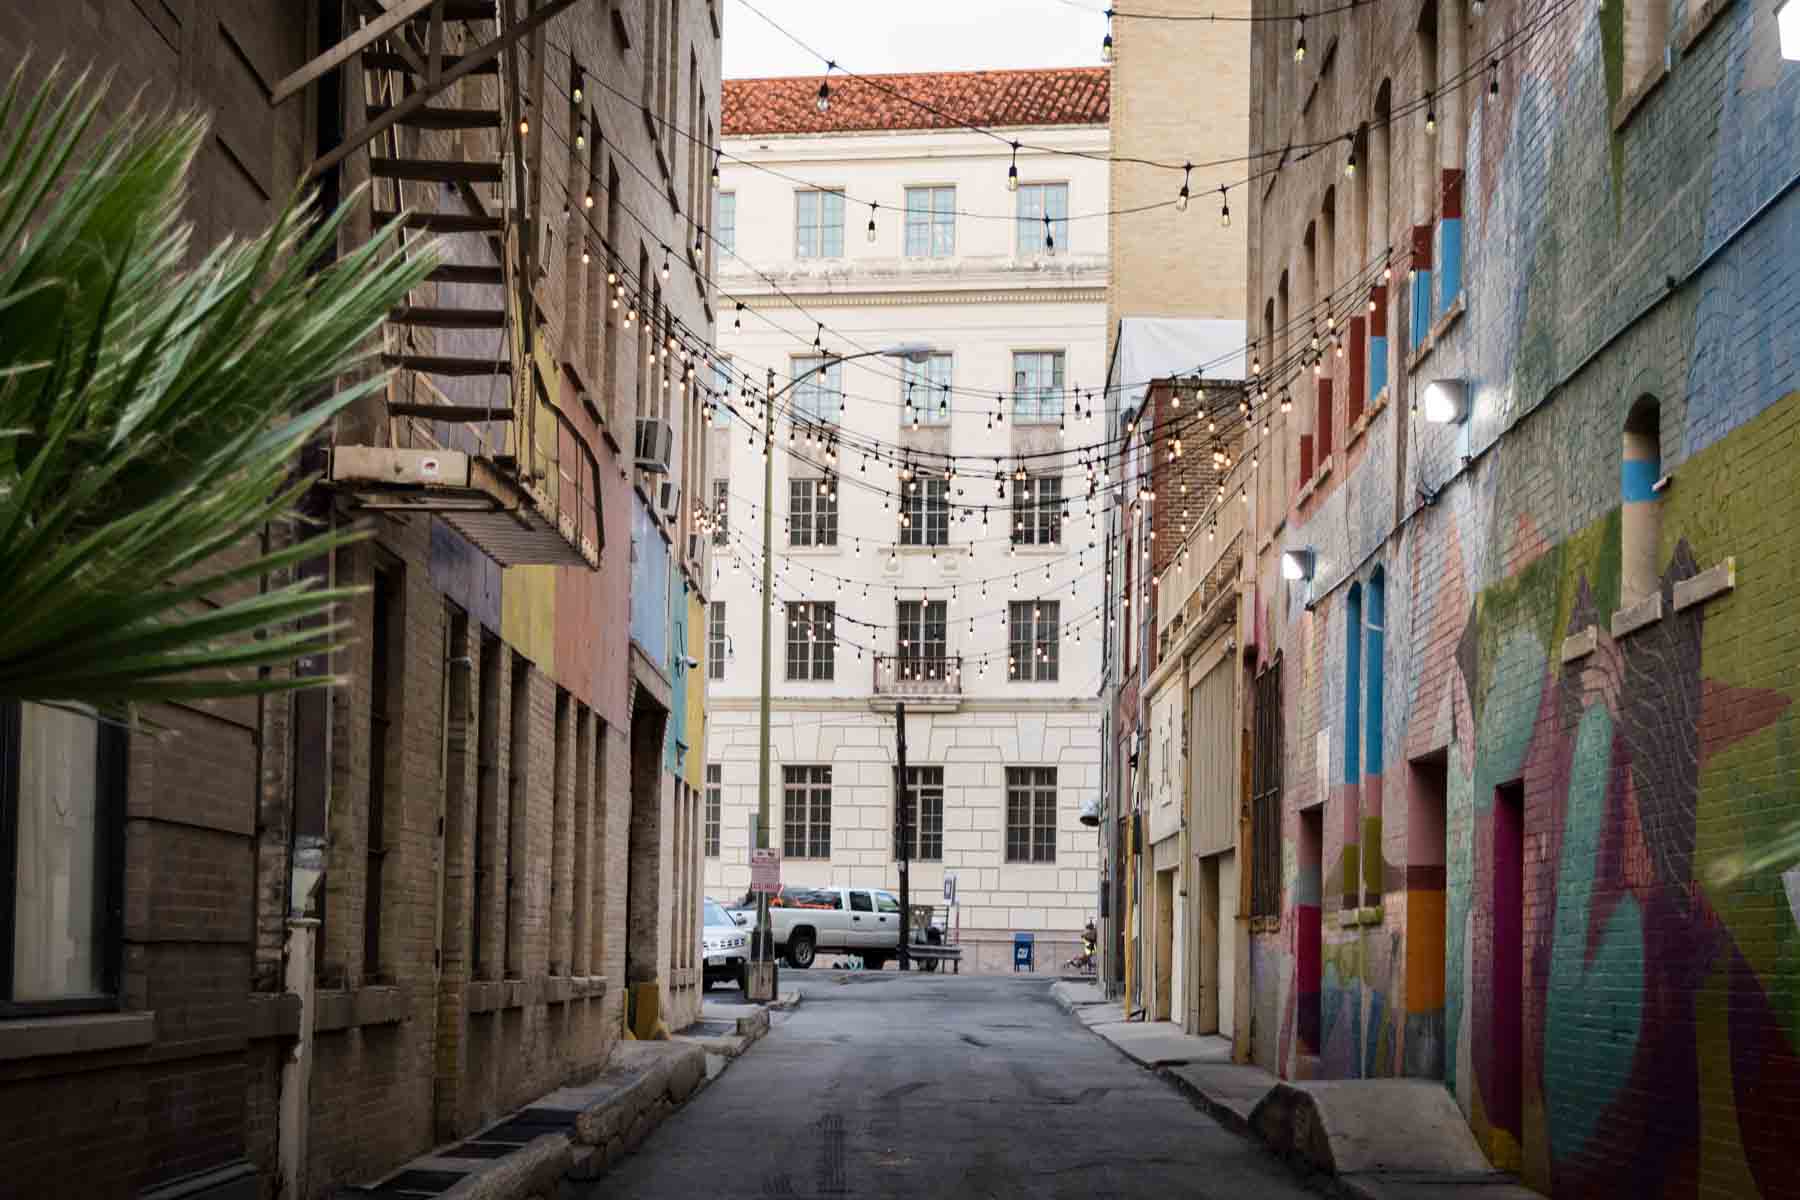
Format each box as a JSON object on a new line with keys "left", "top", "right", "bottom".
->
{"left": 706, "top": 70, "right": 1109, "bottom": 970}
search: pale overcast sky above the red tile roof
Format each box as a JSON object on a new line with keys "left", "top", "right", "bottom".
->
{"left": 724, "top": 0, "right": 1107, "bottom": 79}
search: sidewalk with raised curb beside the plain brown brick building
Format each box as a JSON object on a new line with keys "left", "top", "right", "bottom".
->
{"left": 337, "top": 991, "right": 801, "bottom": 1200}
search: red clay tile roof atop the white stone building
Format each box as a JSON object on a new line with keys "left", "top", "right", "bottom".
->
{"left": 720, "top": 67, "right": 1111, "bottom": 137}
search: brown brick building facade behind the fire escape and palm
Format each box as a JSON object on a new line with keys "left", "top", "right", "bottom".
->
{"left": 0, "top": 0, "right": 720, "bottom": 1196}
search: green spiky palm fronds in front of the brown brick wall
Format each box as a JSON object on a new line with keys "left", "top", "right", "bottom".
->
{"left": 0, "top": 67, "right": 436, "bottom": 709}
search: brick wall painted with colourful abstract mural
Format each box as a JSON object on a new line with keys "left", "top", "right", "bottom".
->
{"left": 1251, "top": 5, "right": 1800, "bottom": 1196}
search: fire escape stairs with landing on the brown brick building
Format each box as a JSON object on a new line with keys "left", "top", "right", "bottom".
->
{"left": 272, "top": 0, "right": 603, "bottom": 569}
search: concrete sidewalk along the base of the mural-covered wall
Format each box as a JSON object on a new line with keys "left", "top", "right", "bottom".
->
{"left": 1051, "top": 981, "right": 1543, "bottom": 1200}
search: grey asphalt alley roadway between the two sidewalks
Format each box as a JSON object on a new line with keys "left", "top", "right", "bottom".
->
{"left": 589, "top": 970, "right": 1312, "bottom": 1200}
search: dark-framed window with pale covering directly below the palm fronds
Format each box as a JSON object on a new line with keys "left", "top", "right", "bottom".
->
{"left": 0, "top": 703, "right": 126, "bottom": 1015}
